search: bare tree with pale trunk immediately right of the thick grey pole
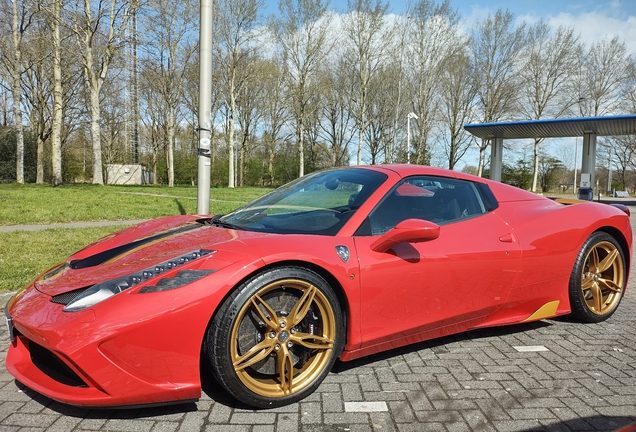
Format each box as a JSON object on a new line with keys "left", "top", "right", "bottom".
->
{"left": 214, "top": 0, "right": 262, "bottom": 188}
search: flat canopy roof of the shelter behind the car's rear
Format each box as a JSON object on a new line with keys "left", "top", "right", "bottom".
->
{"left": 464, "top": 114, "right": 636, "bottom": 139}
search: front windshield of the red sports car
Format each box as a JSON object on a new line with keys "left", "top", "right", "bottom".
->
{"left": 217, "top": 168, "right": 387, "bottom": 235}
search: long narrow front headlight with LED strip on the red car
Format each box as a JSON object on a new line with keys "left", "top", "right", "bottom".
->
{"left": 64, "top": 249, "right": 216, "bottom": 312}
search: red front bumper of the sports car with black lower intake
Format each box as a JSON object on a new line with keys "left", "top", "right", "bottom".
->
{"left": 5, "top": 280, "right": 222, "bottom": 407}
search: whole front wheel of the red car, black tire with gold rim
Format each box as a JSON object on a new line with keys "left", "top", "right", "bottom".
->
{"left": 205, "top": 267, "right": 345, "bottom": 408}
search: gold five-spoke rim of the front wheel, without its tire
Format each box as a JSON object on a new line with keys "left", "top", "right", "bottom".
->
{"left": 230, "top": 279, "right": 337, "bottom": 398}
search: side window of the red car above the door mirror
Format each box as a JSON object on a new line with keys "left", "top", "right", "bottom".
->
{"left": 356, "top": 176, "right": 490, "bottom": 235}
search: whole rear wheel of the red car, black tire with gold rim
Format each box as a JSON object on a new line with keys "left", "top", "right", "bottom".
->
{"left": 569, "top": 232, "right": 627, "bottom": 323}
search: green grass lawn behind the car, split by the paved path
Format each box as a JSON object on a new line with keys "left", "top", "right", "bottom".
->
{"left": 0, "top": 184, "right": 270, "bottom": 292}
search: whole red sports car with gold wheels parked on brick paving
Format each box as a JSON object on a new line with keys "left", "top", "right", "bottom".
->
{"left": 5, "top": 165, "right": 632, "bottom": 407}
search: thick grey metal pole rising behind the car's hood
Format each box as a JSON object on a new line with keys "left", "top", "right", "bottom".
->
{"left": 197, "top": 0, "right": 214, "bottom": 215}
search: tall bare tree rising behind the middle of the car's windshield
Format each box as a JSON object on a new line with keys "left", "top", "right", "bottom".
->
{"left": 270, "top": 0, "right": 336, "bottom": 177}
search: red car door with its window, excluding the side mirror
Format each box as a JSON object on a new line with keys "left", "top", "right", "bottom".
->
{"left": 354, "top": 177, "right": 521, "bottom": 349}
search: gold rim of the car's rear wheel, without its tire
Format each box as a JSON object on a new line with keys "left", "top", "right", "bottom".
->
{"left": 581, "top": 241, "right": 625, "bottom": 315}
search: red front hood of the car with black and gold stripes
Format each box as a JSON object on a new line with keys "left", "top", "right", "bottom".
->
{"left": 35, "top": 216, "right": 272, "bottom": 296}
